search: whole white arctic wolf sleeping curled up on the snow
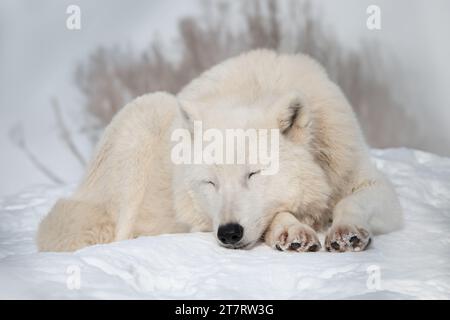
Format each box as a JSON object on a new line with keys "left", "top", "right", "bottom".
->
{"left": 37, "top": 50, "right": 402, "bottom": 252}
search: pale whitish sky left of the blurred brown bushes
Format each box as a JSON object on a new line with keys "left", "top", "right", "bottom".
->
{"left": 0, "top": 0, "right": 197, "bottom": 195}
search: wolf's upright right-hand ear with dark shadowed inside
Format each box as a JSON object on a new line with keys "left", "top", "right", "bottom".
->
{"left": 276, "top": 93, "right": 311, "bottom": 139}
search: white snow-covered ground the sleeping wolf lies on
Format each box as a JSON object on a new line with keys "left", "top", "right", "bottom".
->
{"left": 0, "top": 149, "right": 450, "bottom": 299}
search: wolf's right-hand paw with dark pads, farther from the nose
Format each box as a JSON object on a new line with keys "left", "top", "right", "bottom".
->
{"left": 325, "top": 225, "right": 371, "bottom": 252}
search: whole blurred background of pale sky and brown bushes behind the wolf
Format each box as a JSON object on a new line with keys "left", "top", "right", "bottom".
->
{"left": 0, "top": 0, "right": 450, "bottom": 196}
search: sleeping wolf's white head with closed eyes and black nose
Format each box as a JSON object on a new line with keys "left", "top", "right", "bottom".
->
{"left": 172, "top": 93, "right": 329, "bottom": 248}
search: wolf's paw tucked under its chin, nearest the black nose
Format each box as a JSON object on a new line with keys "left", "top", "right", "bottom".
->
{"left": 265, "top": 223, "right": 322, "bottom": 252}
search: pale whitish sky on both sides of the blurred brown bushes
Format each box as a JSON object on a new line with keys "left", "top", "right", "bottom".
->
{"left": 0, "top": 0, "right": 450, "bottom": 195}
